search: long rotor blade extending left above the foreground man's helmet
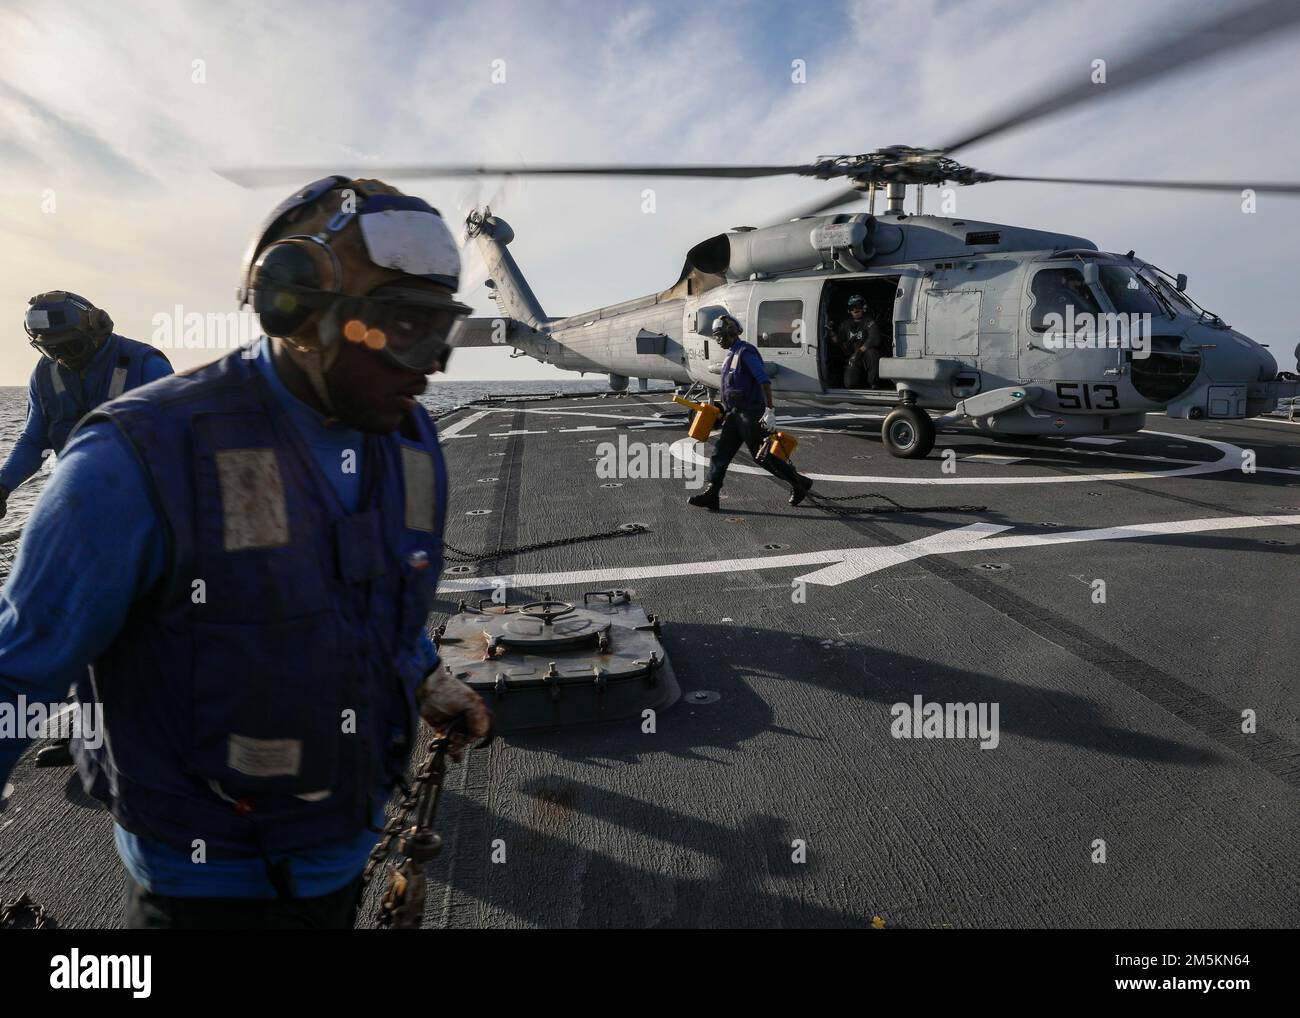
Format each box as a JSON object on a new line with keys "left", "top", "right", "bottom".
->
{"left": 215, "top": 163, "right": 814, "bottom": 187}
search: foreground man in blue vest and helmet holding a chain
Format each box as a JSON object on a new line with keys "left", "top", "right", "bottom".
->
{"left": 0, "top": 177, "right": 490, "bottom": 928}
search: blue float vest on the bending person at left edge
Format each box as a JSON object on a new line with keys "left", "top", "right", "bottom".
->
{"left": 33, "top": 334, "right": 164, "bottom": 452}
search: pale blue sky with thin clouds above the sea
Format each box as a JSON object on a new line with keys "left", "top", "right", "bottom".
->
{"left": 0, "top": 0, "right": 1300, "bottom": 385}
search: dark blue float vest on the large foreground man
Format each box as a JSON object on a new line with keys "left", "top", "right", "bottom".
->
{"left": 73, "top": 351, "right": 447, "bottom": 858}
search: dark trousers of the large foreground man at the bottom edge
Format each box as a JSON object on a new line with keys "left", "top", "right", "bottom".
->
{"left": 126, "top": 876, "right": 361, "bottom": 930}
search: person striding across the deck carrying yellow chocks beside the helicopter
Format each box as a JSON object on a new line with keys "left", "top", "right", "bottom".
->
{"left": 686, "top": 315, "right": 813, "bottom": 510}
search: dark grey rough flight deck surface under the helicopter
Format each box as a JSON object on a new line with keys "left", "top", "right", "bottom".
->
{"left": 0, "top": 393, "right": 1300, "bottom": 927}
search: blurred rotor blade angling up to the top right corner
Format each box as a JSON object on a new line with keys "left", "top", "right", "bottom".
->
{"left": 943, "top": 0, "right": 1300, "bottom": 153}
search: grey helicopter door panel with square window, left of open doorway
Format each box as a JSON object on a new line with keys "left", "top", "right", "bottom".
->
{"left": 745, "top": 278, "right": 822, "bottom": 393}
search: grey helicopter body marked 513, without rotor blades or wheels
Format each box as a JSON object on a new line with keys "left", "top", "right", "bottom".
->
{"left": 467, "top": 213, "right": 1296, "bottom": 434}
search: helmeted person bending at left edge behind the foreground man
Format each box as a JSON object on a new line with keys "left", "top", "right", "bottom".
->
{"left": 0, "top": 290, "right": 172, "bottom": 767}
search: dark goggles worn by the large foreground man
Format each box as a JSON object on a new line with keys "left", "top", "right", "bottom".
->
{"left": 328, "top": 286, "right": 472, "bottom": 374}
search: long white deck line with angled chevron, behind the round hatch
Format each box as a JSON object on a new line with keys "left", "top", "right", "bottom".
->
{"left": 438, "top": 514, "right": 1300, "bottom": 593}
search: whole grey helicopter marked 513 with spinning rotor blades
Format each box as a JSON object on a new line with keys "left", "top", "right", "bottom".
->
{"left": 218, "top": 0, "right": 1300, "bottom": 459}
